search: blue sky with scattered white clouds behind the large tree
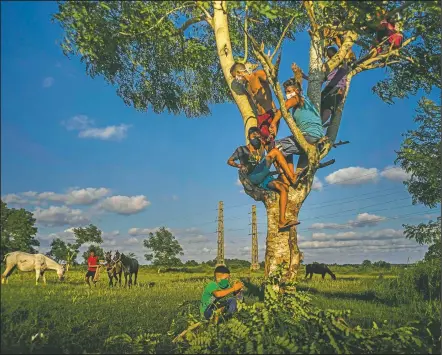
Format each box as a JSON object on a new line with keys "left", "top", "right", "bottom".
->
{"left": 1, "top": 2, "right": 438, "bottom": 263}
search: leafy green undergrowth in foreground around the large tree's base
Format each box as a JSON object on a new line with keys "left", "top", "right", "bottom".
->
{"left": 177, "top": 268, "right": 435, "bottom": 354}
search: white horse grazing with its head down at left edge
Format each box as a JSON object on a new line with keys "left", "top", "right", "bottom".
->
{"left": 2, "top": 251, "right": 65, "bottom": 285}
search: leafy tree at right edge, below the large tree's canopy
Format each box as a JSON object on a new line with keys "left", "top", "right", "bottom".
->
{"left": 396, "top": 98, "right": 442, "bottom": 259}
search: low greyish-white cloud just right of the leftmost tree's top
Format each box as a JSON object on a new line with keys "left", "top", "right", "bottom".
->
{"left": 33, "top": 206, "right": 90, "bottom": 226}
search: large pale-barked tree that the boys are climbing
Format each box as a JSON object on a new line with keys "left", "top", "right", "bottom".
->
{"left": 54, "top": 1, "right": 441, "bottom": 279}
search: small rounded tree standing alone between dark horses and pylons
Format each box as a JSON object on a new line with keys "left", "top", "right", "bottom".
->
{"left": 143, "top": 227, "right": 184, "bottom": 266}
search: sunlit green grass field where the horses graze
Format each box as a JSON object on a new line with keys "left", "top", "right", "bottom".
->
{"left": 1, "top": 266, "right": 440, "bottom": 354}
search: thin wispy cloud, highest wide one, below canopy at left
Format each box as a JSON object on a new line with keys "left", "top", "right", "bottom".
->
{"left": 61, "top": 115, "right": 131, "bottom": 141}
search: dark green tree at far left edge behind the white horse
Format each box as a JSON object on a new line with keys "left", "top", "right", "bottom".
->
{"left": 0, "top": 201, "right": 40, "bottom": 259}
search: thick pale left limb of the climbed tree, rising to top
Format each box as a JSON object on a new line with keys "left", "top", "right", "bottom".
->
{"left": 213, "top": 1, "right": 257, "bottom": 141}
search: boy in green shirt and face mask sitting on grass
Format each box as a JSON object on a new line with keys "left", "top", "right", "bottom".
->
{"left": 200, "top": 265, "right": 244, "bottom": 320}
